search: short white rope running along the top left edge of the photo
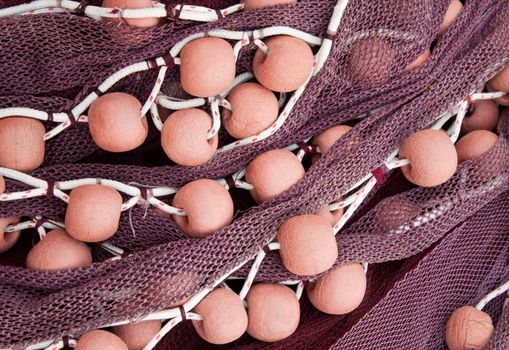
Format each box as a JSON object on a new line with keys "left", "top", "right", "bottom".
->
{"left": 0, "top": 0, "right": 244, "bottom": 22}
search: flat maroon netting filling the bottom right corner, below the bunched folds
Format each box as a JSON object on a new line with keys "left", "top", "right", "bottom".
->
{"left": 153, "top": 192, "right": 509, "bottom": 350}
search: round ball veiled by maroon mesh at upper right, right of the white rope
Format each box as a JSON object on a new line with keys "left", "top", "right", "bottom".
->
{"left": 348, "top": 38, "right": 394, "bottom": 85}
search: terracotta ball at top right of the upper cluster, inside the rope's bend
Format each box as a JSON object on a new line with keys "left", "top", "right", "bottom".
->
{"left": 253, "top": 35, "right": 314, "bottom": 92}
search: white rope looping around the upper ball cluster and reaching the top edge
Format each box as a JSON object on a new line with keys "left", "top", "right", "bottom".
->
{"left": 0, "top": 0, "right": 348, "bottom": 161}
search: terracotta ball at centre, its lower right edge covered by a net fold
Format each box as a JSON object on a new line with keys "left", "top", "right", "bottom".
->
{"left": 246, "top": 149, "right": 305, "bottom": 203}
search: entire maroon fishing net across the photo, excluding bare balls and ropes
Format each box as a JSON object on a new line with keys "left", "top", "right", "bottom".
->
{"left": 0, "top": 0, "right": 509, "bottom": 349}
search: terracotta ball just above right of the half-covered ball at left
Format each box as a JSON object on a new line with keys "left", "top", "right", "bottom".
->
{"left": 65, "top": 185, "right": 122, "bottom": 242}
